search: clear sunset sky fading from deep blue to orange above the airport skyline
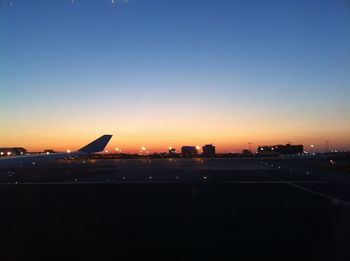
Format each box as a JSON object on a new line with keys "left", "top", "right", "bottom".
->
{"left": 0, "top": 0, "right": 350, "bottom": 152}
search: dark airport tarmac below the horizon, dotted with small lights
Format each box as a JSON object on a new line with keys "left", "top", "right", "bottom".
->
{"left": 0, "top": 157, "right": 350, "bottom": 260}
